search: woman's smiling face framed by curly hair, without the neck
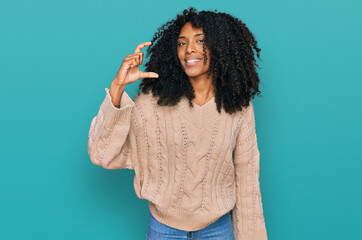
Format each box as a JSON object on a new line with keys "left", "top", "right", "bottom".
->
{"left": 177, "top": 22, "right": 210, "bottom": 78}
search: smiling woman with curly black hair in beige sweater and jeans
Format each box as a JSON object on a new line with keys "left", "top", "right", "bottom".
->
{"left": 88, "top": 7, "right": 267, "bottom": 240}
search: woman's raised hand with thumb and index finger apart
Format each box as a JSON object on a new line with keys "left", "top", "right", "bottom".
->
{"left": 113, "top": 42, "right": 158, "bottom": 87}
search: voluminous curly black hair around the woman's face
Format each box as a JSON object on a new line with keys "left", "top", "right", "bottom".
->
{"left": 139, "top": 7, "right": 261, "bottom": 114}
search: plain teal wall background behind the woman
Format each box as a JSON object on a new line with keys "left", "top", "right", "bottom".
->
{"left": 0, "top": 0, "right": 362, "bottom": 240}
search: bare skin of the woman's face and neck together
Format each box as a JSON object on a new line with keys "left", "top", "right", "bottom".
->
{"left": 177, "top": 22, "right": 215, "bottom": 106}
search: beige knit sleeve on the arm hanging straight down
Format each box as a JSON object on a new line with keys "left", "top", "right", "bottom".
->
{"left": 231, "top": 101, "right": 267, "bottom": 240}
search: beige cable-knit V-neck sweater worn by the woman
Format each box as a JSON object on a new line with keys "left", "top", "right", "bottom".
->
{"left": 88, "top": 88, "right": 267, "bottom": 240}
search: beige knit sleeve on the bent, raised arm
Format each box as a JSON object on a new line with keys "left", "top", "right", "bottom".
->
{"left": 87, "top": 88, "right": 135, "bottom": 169}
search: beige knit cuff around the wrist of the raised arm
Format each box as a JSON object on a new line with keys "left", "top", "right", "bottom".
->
{"left": 100, "top": 88, "right": 135, "bottom": 126}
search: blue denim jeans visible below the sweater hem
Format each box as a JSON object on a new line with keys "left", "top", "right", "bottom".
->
{"left": 146, "top": 212, "right": 235, "bottom": 240}
